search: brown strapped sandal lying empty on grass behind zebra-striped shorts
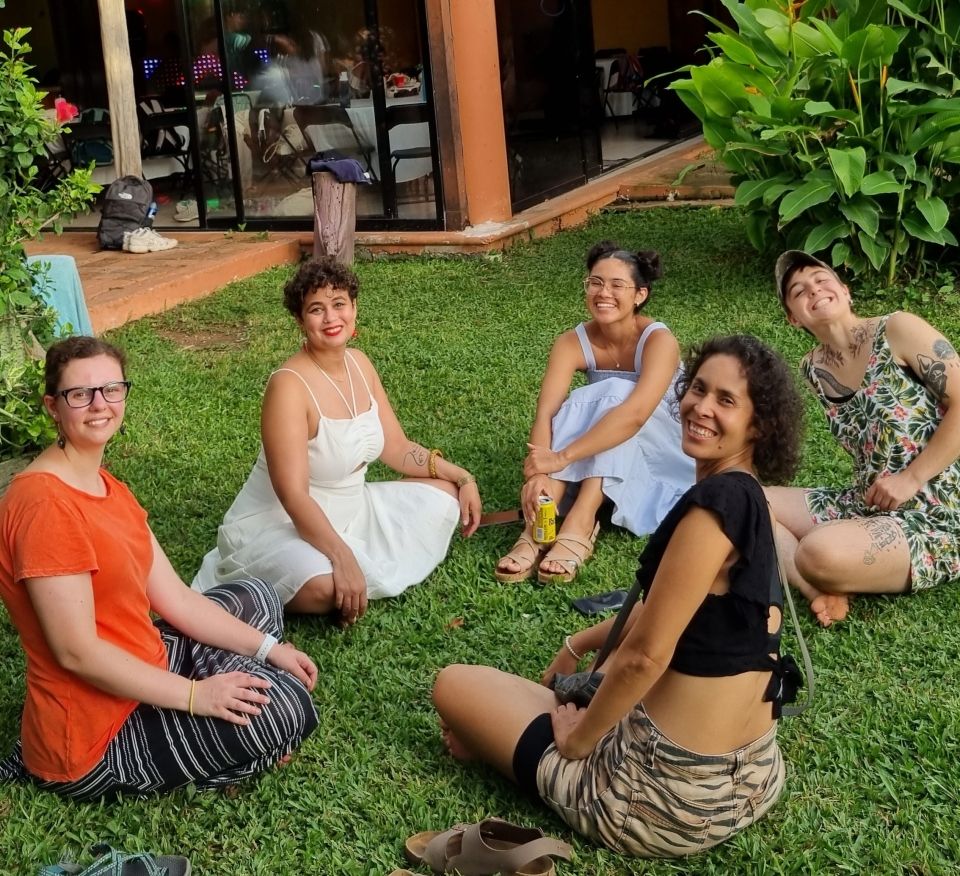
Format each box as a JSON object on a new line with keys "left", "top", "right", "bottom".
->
{"left": 406, "top": 818, "right": 572, "bottom": 876}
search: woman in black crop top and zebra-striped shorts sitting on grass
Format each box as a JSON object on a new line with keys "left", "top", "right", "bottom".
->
{"left": 434, "top": 336, "right": 801, "bottom": 857}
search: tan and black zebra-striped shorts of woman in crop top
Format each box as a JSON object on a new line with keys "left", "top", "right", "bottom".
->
{"left": 537, "top": 705, "right": 784, "bottom": 858}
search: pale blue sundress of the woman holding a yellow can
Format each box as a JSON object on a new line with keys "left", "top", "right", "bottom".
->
{"left": 551, "top": 322, "right": 694, "bottom": 535}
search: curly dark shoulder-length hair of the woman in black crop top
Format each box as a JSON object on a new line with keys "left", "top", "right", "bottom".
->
{"left": 676, "top": 335, "right": 803, "bottom": 484}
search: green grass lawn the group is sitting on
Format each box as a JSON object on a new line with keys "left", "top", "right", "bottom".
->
{"left": 0, "top": 208, "right": 960, "bottom": 876}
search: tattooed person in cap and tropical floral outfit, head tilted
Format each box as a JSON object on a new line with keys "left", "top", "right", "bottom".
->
{"left": 767, "top": 250, "right": 960, "bottom": 626}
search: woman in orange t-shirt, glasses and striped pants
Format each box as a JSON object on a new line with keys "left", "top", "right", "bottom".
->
{"left": 0, "top": 337, "right": 317, "bottom": 798}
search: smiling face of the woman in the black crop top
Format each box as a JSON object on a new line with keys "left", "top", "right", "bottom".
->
{"left": 680, "top": 353, "right": 754, "bottom": 477}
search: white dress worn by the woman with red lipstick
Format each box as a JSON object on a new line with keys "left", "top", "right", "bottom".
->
{"left": 192, "top": 352, "right": 460, "bottom": 603}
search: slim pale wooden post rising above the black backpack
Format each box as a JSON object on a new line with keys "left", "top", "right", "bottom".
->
{"left": 97, "top": 0, "right": 143, "bottom": 177}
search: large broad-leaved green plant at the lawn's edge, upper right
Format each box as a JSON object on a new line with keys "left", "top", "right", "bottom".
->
{"left": 672, "top": 0, "right": 960, "bottom": 285}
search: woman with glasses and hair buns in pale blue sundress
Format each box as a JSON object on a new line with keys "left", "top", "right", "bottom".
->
{"left": 495, "top": 240, "right": 694, "bottom": 583}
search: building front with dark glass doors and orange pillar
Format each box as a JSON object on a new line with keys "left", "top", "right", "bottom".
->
{"left": 0, "top": 0, "right": 721, "bottom": 230}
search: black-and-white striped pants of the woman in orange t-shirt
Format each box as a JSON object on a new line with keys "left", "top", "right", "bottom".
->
{"left": 0, "top": 578, "right": 317, "bottom": 800}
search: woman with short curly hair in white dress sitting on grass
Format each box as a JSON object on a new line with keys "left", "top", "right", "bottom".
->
{"left": 193, "top": 257, "right": 480, "bottom": 624}
